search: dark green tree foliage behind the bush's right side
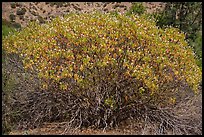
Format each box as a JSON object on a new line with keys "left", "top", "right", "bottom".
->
{"left": 154, "top": 2, "right": 202, "bottom": 66}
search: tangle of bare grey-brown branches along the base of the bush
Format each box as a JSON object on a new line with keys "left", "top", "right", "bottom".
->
{"left": 7, "top": 80, "right": 202, "bottom": 134}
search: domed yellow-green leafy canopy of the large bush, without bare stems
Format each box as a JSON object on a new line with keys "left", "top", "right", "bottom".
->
{"left": 3, "top": 13, "right": 201, "bottom": 95}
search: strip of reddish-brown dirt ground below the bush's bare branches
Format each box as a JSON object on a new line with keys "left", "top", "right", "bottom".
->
{"left": 9, "top": 120, "right": 153, "bottom": 135}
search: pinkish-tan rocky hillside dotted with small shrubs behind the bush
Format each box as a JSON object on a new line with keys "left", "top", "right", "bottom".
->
{"left": 2, "top": 2, "right": 164, "bottom": 27}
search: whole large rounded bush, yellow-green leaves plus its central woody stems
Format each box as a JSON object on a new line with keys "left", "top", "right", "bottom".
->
{"left": 3, "top": 13, "right": 201, "bottom": 131}
